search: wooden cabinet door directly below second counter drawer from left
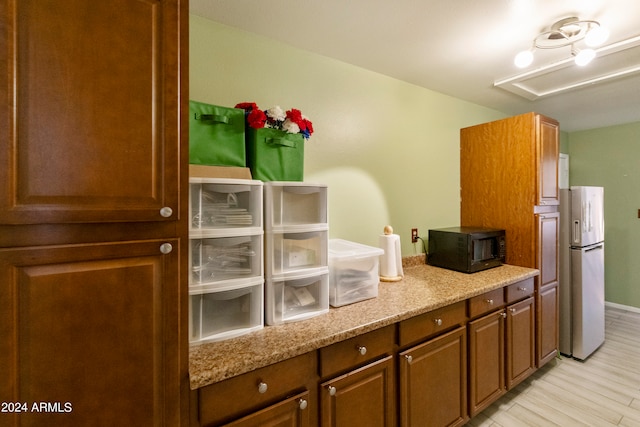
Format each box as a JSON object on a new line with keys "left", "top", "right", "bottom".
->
{"left": 320, "top": 356, "right": 396, "bottom": 427}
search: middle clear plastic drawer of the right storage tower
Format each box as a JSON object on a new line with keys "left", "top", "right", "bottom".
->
{"left": 265, "top": 230, "right": 328, "bottom": 276}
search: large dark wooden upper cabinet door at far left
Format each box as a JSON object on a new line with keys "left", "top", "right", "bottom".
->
{"left": 0, "top": 0, "right": 187, "bottom": 224}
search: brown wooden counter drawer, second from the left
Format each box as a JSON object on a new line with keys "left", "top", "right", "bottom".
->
{"left": 319, "top": 325, "right": 395, "bottom": 377}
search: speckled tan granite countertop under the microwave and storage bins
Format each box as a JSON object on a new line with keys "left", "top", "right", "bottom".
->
{"left": 189, "top": 255, "right": 538, "bottom": 390}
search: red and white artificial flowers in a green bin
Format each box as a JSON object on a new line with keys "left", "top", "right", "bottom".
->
{"left": 236, "top": 102, "right": 313, "bottom": 139}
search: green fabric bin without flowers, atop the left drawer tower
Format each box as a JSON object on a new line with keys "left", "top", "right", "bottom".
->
{"left": 189, "top": 101, "right": 247, "bottom": 167}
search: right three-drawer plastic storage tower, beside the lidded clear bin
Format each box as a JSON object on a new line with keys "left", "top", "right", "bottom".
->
{"left": 264, "top": 181, "right": 329, "bottom": 325}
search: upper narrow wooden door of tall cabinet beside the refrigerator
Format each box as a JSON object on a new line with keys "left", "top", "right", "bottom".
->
{"left": 536, "top": 115, "right": 560, "bottom": 205}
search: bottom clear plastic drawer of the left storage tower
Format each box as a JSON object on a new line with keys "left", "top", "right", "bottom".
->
{"left": 189, "top": 279, "right": 264, "bottom": 343}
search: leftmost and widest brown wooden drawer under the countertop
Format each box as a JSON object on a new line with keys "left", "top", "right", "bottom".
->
{"left": 198, "top": 352, "right": 318, "bottom": 426}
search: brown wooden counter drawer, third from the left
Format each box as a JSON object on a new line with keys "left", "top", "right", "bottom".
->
{"left": 399, "top": 301, "right": 466, "bottom": 346}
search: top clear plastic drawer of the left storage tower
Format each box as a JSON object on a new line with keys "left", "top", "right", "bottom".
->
{"left": 189, "top": 178, "right": 263, "bottom": 237}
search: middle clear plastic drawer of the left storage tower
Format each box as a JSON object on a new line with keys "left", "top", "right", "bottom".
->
{"left": 189, "top": 234, "right": 264, "bottom": 286}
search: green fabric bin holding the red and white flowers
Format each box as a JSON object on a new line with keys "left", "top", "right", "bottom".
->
{"left": 246, "top": 127, "right": 304, "bottom": 181}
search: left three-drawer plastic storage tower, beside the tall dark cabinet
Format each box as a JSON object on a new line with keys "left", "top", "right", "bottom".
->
{"left": 189, "top": 178, "right": 264, "bottom": 343}
